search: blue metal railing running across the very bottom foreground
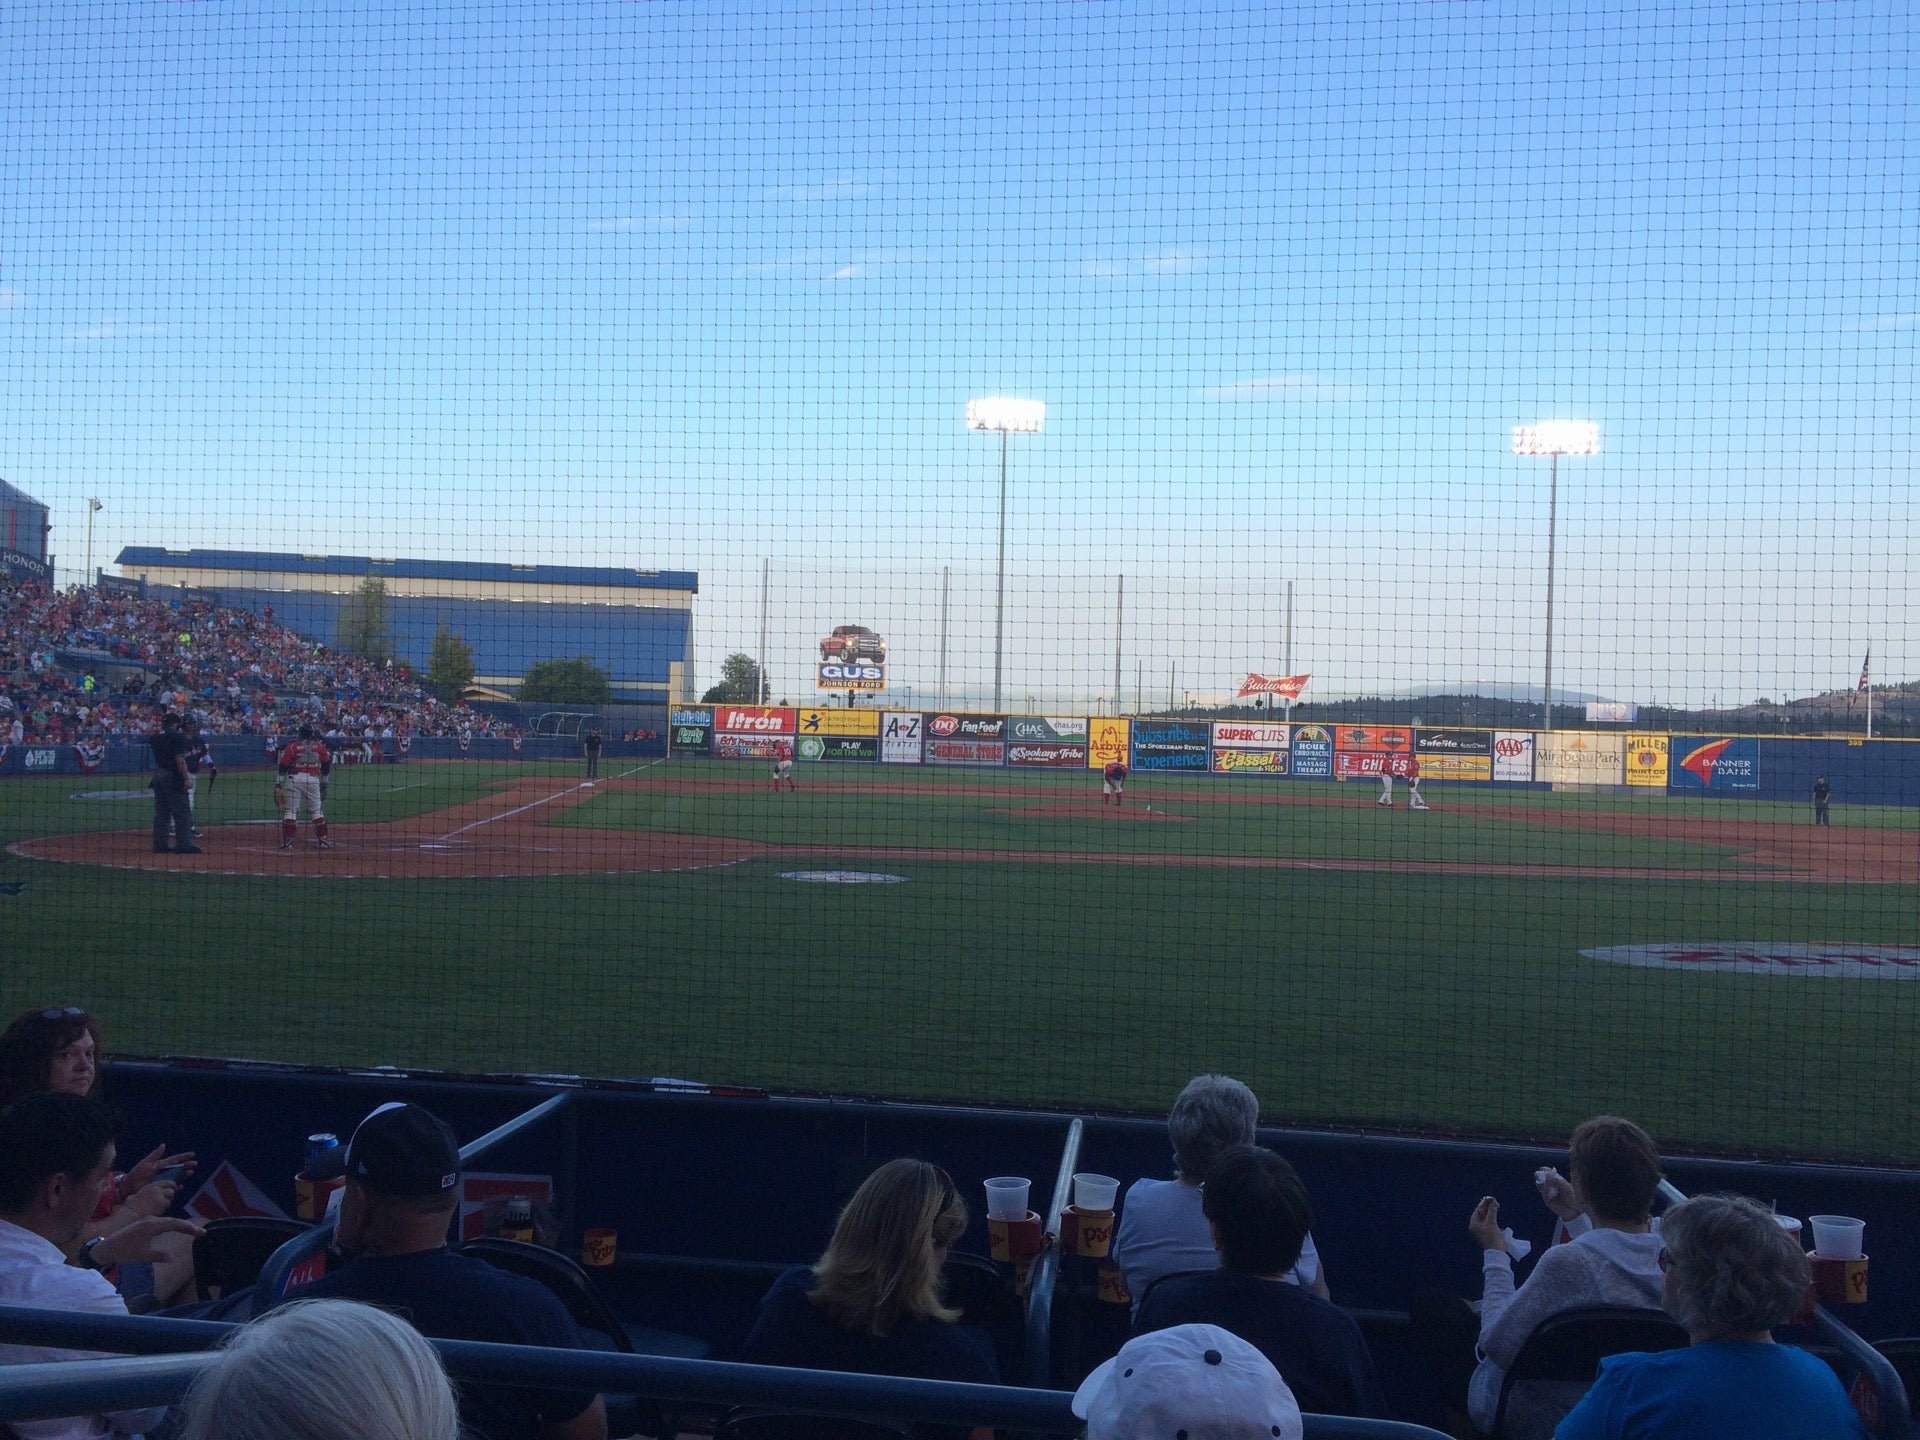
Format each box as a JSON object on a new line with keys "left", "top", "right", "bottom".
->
{"left": 0, "top": 1306, "right": 1446, "bottom": 1440}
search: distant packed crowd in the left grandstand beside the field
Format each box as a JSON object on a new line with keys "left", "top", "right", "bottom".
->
{"left": 0, "top": 578, "right": 520, "bottom": 745}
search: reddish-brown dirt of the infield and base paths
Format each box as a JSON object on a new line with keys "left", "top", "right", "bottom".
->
{"left": 8, "top": 776, "right": 1920, "bottom": 885}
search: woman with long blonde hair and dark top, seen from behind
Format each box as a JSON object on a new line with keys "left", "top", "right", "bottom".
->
{"left": 741, "top": 1160, "right": 1000, "bottom": 1436}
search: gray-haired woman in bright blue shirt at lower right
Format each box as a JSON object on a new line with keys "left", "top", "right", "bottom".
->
{"left": 1553, "top": 1194, "right": 1866, "bottom": 1440}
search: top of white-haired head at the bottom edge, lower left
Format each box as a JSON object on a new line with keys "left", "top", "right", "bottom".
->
{"left": 180, "top": 1300, "right": 461, "bottom": 1440}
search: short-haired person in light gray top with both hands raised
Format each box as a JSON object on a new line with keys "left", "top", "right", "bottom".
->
{"left": 1413, "top": 1116, "right": 1661, "bottom": 1440}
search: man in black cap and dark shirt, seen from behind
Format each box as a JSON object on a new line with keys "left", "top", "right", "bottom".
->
{"left": 296, "top": 1104, "right": 607, "bottom": 1440}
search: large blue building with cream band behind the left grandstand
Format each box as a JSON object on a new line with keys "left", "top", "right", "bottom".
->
{"left": 117, "top": 545, "right": 699, "bottom": 703}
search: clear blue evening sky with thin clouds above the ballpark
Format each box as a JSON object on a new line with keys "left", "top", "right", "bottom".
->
{"left": 0, "top": 0, "right": 1920, "bottom": 703}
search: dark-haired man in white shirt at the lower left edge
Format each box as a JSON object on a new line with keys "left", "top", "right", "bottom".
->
{"left": 0, "top": 1091, "right": 200, "bottom": 1440}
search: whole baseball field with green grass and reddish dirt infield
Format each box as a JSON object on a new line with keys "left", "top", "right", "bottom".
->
{"left": 0, "top": 760, "right": 1920, "bottom": 1162}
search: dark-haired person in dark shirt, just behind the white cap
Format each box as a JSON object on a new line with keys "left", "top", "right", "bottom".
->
{"left": 1133, "top": 1144, "right": 1388, "bottom": 1419}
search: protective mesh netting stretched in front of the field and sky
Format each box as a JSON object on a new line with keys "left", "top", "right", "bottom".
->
{"left": 0, "top": 0, "right": 1920, "bottom": 1160}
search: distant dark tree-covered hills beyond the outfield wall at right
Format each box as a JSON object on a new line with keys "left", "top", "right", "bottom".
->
{"left": 1181, "top": 682, "right": 1920, "bottom": 737}
